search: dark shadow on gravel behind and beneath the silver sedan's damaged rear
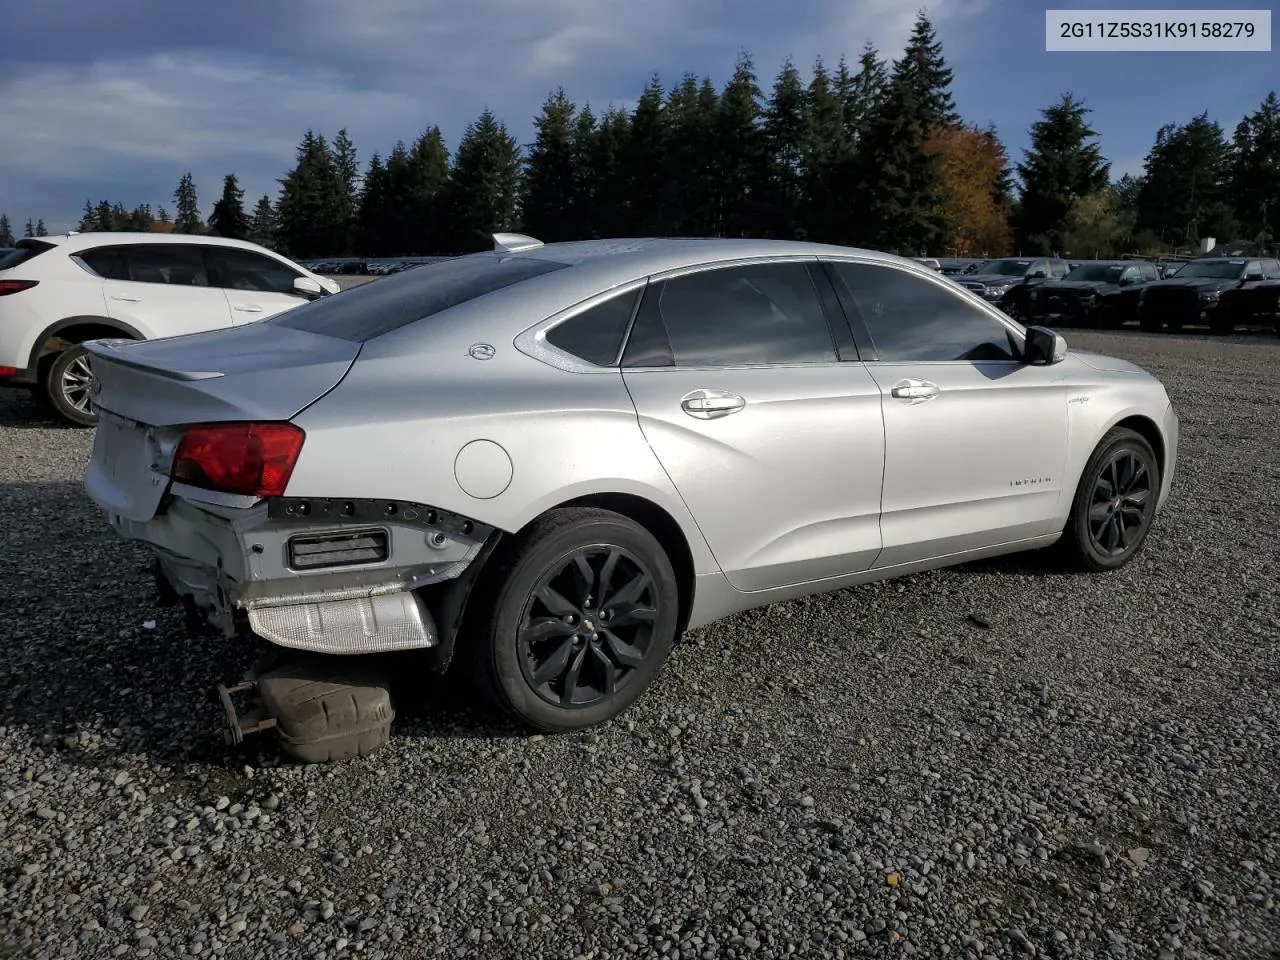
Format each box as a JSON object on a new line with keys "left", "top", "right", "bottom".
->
{"left": 0, "top": 483, "right": 520, "bottom": 768}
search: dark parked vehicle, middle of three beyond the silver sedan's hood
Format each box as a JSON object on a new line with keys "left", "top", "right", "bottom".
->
{"left": 1025, "top": 260, "right": 1160, "bottom": 330}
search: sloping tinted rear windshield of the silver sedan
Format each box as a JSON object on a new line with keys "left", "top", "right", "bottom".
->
{"left": 262, "top": 253, "right": 568, "bottom": 343}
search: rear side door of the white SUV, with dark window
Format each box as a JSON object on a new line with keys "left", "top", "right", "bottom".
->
{"left": 91, "top": 243, "right": 232, "bottom": 339}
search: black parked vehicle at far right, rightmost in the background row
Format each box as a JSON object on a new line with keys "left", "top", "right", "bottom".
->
{"left": 1138, "top": 257, "right": 1280, "bottom": 333}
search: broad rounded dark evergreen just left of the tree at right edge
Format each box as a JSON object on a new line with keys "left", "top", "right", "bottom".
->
{"left": 1138, "top": 113, "right": 1235, "bottom": 244}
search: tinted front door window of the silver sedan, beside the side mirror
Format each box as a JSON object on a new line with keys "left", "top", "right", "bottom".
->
{"left": 835, "top": 264, "right": 1015, "bottom": 361}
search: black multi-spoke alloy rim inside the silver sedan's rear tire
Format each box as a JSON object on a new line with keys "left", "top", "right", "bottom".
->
{"left": 520, "top": 544, "right": 659, "bottom": 709}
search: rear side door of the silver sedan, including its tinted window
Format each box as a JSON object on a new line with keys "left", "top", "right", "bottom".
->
{"left": 622, "top": 260, "right": 884, "bottom": 591}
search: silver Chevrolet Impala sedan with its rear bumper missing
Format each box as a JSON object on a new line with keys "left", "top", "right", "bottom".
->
{"left": 84, "top": 234, "right": 1178, "bottom": 731}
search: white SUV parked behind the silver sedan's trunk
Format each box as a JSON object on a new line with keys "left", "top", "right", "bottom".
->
{"left": 0, "top": 233, "right": 340, "bottom": 426}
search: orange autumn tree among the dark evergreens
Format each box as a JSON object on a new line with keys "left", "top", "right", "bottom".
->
{"left": 925, "top": 125, "right": 1012, "bottom": 257}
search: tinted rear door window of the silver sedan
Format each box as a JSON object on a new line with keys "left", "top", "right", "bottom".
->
{"left": 627, "top": 264, "right": 838, "bottom": 366}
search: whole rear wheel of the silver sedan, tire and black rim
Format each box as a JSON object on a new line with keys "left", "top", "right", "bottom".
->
{"left": 470, "top": 508, "right": 680, "bottom": 732}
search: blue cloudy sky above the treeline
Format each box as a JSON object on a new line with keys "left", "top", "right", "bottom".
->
{"left": 0, "top": 0, "right": 1280, "bottom": 232}
